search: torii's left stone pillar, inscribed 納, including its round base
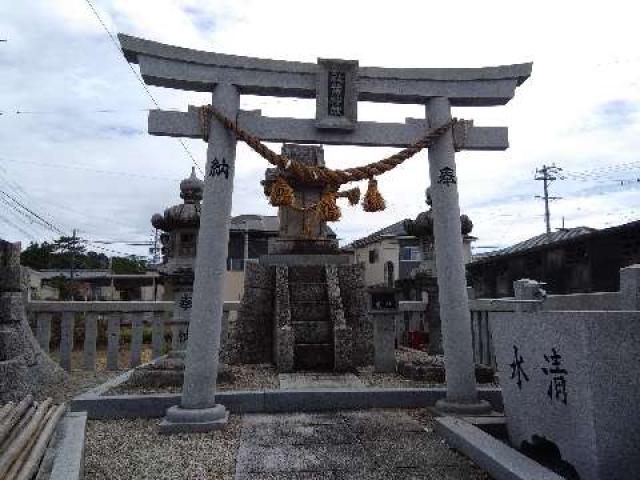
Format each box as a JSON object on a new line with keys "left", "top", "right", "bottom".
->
{"left": 160, "top": 84, "right": 240, "bottom": 433}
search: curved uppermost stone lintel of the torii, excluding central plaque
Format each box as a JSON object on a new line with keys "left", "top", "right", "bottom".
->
{"left": 118, "top": 34, "right": 532, "bottom": 106}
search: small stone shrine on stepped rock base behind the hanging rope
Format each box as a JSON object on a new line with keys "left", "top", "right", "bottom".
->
{"left": 229, "top": 144, "right": 373, "bottom": 372}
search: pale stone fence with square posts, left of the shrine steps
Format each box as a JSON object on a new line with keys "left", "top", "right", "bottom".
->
{"left": 27, "top": 301, "right": 240, "bottom": 370}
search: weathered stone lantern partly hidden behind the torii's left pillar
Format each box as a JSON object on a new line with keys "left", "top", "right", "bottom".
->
{"left": 151, "top": 169, "right": 204, "bottom": 351}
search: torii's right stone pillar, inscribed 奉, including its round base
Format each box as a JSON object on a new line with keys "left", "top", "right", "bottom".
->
{"left": 426, "top": 97, "right": 491, "bottom": 414}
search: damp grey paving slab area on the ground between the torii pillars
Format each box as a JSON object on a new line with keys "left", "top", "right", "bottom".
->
{"left": 235, "top": 410, "right": 487, "bottom": 480}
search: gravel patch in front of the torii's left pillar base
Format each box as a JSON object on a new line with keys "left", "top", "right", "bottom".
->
{"left": 85, "top": 415, "right": 241, "bottom": 480}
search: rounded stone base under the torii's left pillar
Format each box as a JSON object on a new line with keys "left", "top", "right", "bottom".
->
{"left": 160, "top": 404, "right": 229, "bottom": 433}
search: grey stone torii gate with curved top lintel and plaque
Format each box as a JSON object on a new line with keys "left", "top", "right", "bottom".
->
{"left": 119, "top": 34, "right": 532, "bottom": 432}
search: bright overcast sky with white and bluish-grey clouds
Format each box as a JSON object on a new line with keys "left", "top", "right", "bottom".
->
{"left": 0, "top": 0, "right": 640, "bottom": 260}
